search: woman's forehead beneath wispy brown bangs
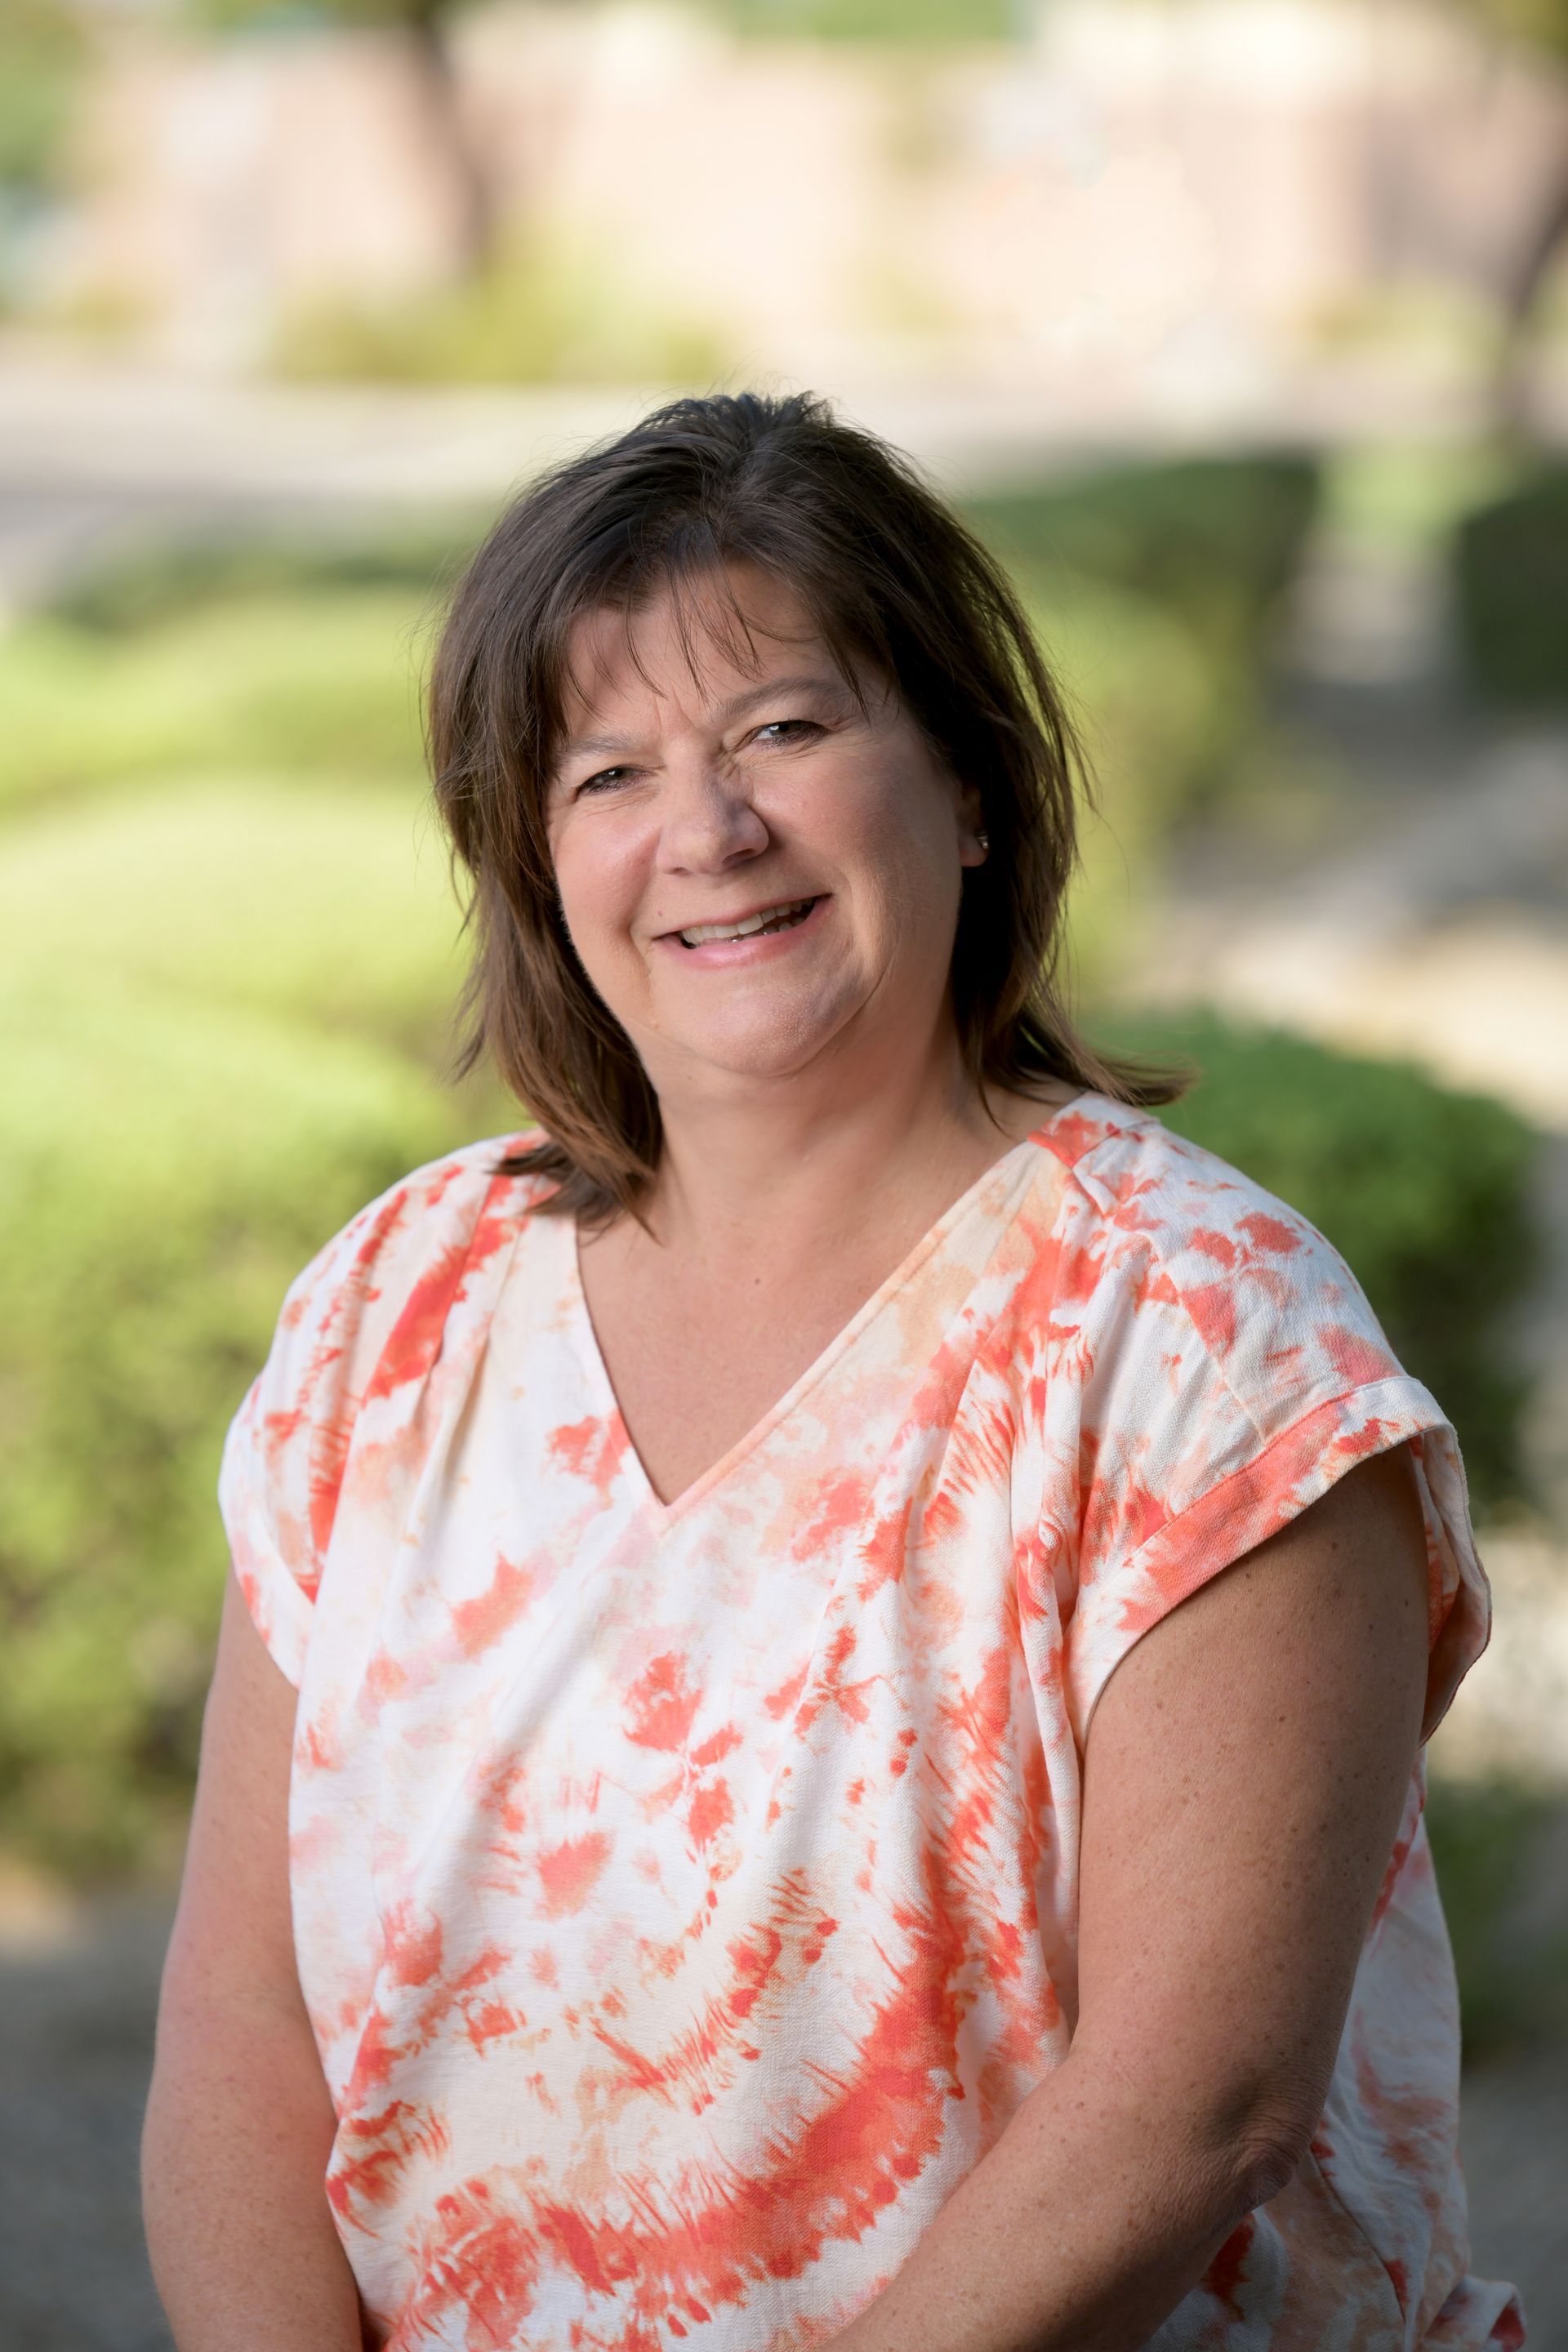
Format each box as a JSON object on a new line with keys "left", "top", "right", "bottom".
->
{"left": 562, "top": 564, "right": 837, "bottom": 734}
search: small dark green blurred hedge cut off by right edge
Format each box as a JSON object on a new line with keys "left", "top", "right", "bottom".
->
{"left": 1453, "top": 466, "right": 1568, "bottom": 703}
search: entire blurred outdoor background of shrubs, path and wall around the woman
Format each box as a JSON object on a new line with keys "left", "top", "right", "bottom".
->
{"left": 0, "top": 0, "right": 1568, "bottom": 2352}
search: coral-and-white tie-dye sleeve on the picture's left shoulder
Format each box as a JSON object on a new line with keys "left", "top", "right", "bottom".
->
{"left": 219, "top": 1136, "right": 542, "bottom": 1684}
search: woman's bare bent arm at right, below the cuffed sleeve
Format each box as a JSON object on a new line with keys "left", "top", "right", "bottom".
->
{"left": 835, "top": 1446, "right": 1427, "bottom": 2352}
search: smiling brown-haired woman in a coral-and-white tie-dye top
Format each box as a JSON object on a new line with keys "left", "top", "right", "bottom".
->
{"left": 145, "top": 398, "right": 1523, "bottom": 2352}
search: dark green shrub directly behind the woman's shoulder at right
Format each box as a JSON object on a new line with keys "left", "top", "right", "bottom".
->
{"left": 1102, "top": 1016, "right": 1539, "bottom": 1505}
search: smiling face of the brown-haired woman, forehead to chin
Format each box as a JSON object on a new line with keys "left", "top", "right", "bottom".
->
{"left": 548, "top": 567, "right": 982, "bottom": 1094}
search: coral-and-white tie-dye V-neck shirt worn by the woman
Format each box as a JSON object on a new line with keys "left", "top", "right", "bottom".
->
{"left": 221, "top": 1094, "right": 1523, "bottom": 2352}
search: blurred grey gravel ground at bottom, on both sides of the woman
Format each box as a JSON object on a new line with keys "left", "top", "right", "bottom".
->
{"left": 0, "top": 1903, "right": 1568, "bottom": 2352}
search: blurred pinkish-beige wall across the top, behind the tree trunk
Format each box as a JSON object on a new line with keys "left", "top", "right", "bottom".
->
{"left": 39, "top": 0, "right": 1568, "bottom": 379}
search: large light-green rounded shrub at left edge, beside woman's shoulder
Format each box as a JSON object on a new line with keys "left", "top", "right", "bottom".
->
{"left": 0, "top": 990, "right": 465, "bottom": 1870}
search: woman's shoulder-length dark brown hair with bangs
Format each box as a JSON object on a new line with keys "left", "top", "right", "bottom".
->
{"left": 428, "top": 393, "right": 1183, "bottom": 1223}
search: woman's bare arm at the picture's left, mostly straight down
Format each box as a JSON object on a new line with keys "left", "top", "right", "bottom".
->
{"left": 141, "top": 1576, "right": 362, "bottom": 2352}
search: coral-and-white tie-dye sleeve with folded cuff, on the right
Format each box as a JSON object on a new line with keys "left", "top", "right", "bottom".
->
{"left": 1065, "top": 1122, "right": 1490, "bottom": 1738}
